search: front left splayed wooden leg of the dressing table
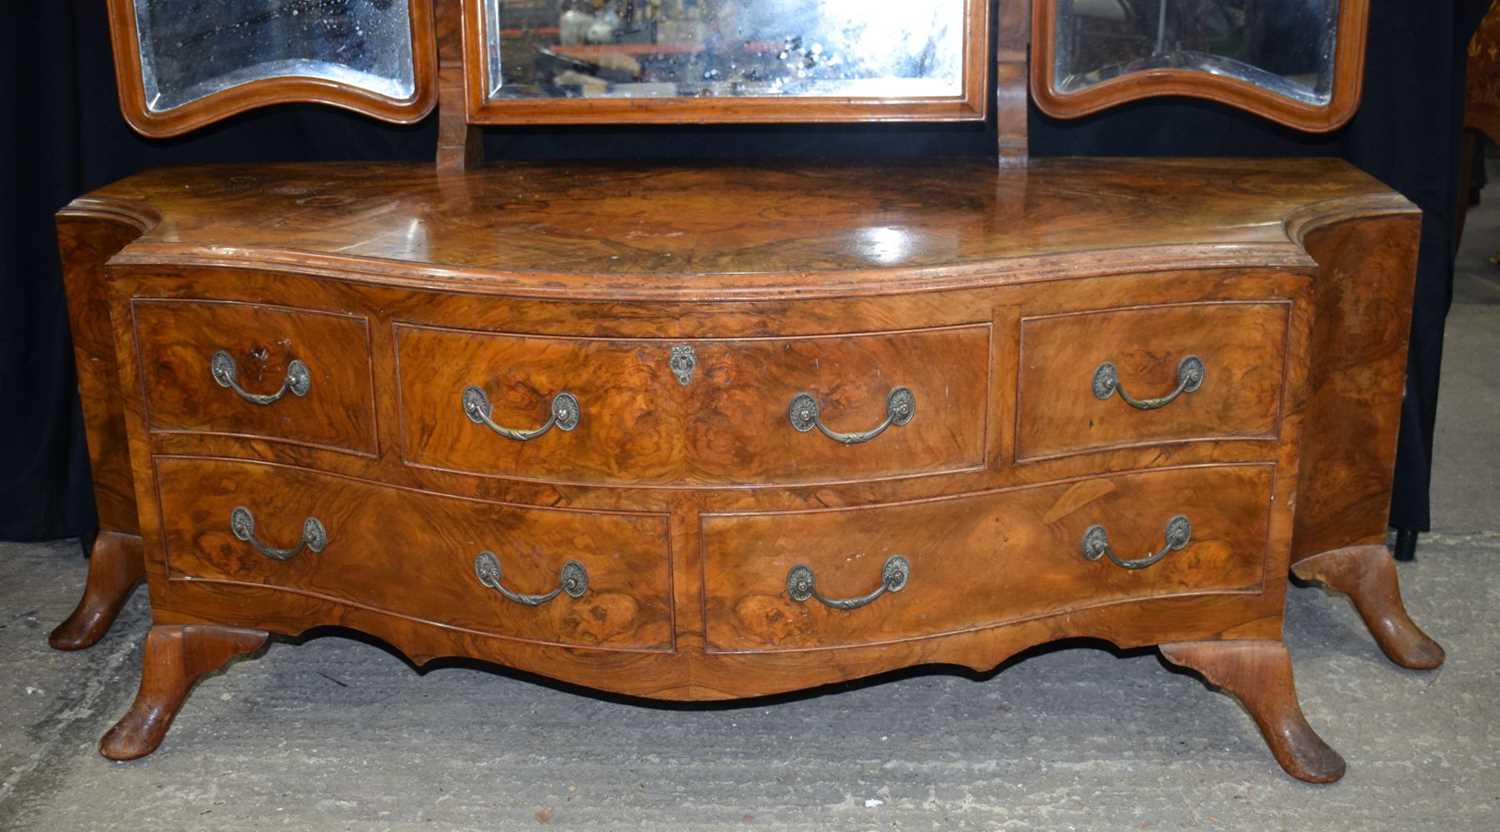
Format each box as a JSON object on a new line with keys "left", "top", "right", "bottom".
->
{"left": 99, "top": 624, "right": 270, "bottom": 760}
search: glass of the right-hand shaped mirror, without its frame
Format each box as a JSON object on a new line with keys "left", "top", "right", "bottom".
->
{"left": 1053, "top": 0, "right": 1340, "bottom": 105}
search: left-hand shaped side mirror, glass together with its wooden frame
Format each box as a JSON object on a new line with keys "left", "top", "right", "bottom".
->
{"left": 110, "top": 0, "right": 434, "bottom": 135}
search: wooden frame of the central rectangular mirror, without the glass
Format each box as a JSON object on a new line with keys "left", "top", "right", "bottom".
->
{"left": 464, "top": 0, "right": 990, "bottom": 124}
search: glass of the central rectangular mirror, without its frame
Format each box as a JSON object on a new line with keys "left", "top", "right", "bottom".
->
{"left": 483, "top": 0, "right": 966, "bottom": 99}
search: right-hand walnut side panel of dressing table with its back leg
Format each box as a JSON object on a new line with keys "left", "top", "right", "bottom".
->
{"left": 1292, "top": 216, "right": 1445, "bottom": 670}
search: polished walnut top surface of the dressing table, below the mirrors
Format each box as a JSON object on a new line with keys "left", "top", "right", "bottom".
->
{"left": 63, "top": 159, "right": 1416, "bottom": 298}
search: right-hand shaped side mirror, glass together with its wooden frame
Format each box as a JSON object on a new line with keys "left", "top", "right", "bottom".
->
{"left": 1034, "top": 0, "right": 1367, "bottom": 129}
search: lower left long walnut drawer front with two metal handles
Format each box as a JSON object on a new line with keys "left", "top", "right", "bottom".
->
{"left": 156, "top": 457, "right": 672, "bottom": 651}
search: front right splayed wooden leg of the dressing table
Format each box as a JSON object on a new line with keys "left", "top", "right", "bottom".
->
{"left": 1161, "top": 642, "right": 1344, "bottom": 783}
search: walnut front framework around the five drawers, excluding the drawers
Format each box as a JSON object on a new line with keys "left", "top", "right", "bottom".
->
{"left": 111, "top": 262, "right": 1311, "bottom": 699}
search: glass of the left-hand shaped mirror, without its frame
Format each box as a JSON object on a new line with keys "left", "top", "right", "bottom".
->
{"left": 135, "top": 0, "right": 416, "bottom": 112}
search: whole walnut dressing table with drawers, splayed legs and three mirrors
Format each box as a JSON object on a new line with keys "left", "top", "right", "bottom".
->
{"left": 53, "top": 0, "right": 1443, "bottom": 783}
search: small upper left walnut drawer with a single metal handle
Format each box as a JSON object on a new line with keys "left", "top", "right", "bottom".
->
{"left": 131, "top": 298, "right": 377, "bottom": 454}
